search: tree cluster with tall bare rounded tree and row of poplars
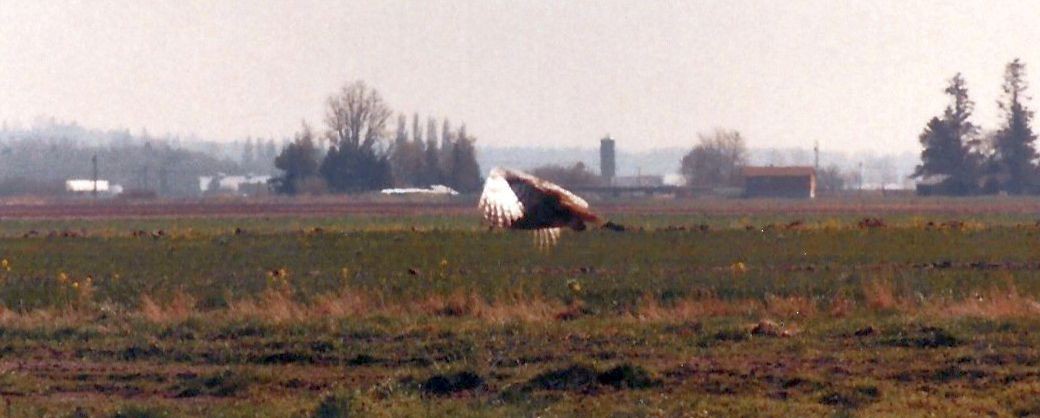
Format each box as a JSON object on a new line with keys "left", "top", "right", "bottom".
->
{"left": 271, "top": 81, "right": 483, "bottom": 194}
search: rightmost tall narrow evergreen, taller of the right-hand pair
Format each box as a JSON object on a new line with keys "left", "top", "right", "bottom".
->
{"left": 989, "top": 58, "right": 1037, "bottom": 194}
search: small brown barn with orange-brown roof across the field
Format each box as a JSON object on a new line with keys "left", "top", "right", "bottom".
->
{"left": 740, "top": 166, "right": 816, "bottom": 199}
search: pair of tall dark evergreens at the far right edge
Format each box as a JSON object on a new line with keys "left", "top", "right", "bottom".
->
{"left": 911, "top": 58, "right": 1040, "bottom": 195}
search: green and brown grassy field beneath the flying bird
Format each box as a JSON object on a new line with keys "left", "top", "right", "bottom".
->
{"left": 0, "top": 200, "right": 1040, "bottom": 417}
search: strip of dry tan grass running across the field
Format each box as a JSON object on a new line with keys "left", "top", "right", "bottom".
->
{"left": 0, "top": 279, "right": 1040, "bottom": 328}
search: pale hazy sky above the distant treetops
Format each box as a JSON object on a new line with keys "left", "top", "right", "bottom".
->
{"left": 0, "top": 0, "right": 1040, "bottom": 152}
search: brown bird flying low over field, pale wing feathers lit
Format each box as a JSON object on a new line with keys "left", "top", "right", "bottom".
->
{"left": 477, "top": 167, "right": 624, "bottom": 247}
